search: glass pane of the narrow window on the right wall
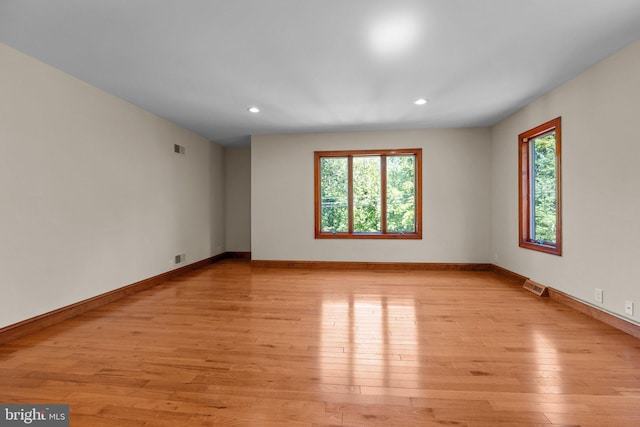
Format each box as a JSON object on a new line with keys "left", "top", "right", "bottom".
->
{"left": 530, "top": 132, "right": 557, "bottom": 244}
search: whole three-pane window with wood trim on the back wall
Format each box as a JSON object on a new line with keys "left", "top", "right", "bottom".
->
{"left": 315, "top": 148, "right": 422, "bottom": 239}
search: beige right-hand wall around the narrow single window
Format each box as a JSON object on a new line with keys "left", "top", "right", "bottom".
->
{"left": 492, "top": 38, "right": 640, "bottom": 322}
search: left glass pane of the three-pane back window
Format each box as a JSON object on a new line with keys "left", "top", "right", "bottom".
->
{"left": 320, "top": 157, "right": 349, "bottom": 233}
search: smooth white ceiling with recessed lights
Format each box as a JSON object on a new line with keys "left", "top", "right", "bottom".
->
{"left": 0, "top": 0, "right": 640, "bottom": 146}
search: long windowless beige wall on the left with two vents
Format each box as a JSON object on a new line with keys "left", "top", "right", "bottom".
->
{"left": 0, "top": 44, "right": 225, "bottom": 327}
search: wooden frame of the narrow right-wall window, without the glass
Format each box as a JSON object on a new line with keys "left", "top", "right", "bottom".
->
{"left": 518, "top": 117, "right": 562, "bottom": 256}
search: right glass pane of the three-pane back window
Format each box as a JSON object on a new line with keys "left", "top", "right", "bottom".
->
{"left": 387, "top": 155, "right": 416, "bottom": 233}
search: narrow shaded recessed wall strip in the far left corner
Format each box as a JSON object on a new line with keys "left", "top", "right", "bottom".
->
{"left": 224, "top": 147, "right": 251, "bottom": 252}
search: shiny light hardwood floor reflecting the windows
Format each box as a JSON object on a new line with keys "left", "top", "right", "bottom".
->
{"left": 0, "top": 260, "right": 640, "bottom": 427}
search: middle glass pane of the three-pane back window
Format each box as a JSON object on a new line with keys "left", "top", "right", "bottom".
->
{"left": 353, "top": 156, "right": 382, "bottom": 233}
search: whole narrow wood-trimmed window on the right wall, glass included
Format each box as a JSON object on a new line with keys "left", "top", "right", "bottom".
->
{"left": 518, "top": 117, "right": 562, "bottom": 255}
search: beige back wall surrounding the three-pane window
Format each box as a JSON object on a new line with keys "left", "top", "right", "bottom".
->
{"left": 251, "top": 129, "right": 491, "bottom": 263}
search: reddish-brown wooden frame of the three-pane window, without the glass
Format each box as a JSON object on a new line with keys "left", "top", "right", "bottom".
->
{"left": 314, "top": 148, "right": 422, "bottom": 239}
